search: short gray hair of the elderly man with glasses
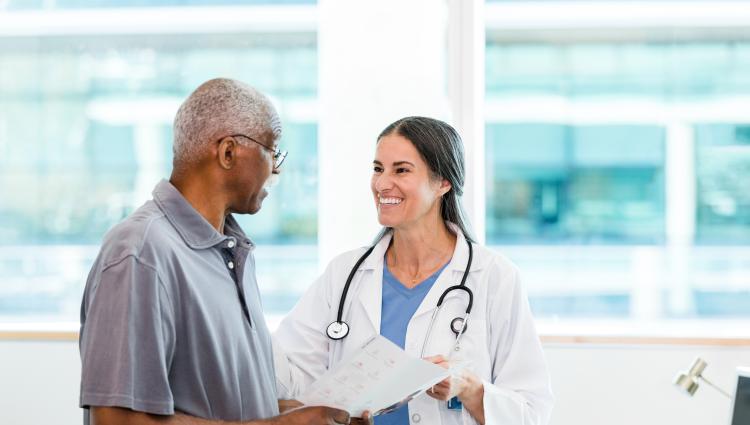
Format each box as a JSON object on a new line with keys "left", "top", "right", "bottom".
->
{"left": 172, "top": 78, "right": 281, "bottom": 166}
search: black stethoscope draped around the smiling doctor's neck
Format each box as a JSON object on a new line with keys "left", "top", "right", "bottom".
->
{"left": 326, "top": 238, "right": 474, "bottom": 357}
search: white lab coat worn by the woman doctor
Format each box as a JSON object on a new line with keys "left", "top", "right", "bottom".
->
{"left": 274, "top": 224, "right": 553, "bottom": 425}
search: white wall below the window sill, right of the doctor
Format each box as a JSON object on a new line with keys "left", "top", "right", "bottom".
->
{"left": 545, "top": 344, "right": 750, "bottom": 425}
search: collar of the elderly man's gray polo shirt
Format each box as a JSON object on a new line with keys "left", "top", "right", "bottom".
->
{"left": 152, "top": 180, "right": 253, "bottom": 249}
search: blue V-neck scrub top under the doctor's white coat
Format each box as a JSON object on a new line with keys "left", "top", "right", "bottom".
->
{"left": 375, "top": 259, "right": 448, "bottom": 425}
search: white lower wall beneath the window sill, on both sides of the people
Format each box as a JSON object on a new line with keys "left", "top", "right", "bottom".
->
{"left": 0, "top": 341, "right": 750, "bottom": 425}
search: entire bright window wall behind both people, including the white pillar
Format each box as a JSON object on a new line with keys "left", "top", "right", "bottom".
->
{"left": 0, "top": 0, "right": 750, "bottom": 322}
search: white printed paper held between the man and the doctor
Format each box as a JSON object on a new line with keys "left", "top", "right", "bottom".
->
{"left": 297, "top": 335, "right": 450, "bottom": 417}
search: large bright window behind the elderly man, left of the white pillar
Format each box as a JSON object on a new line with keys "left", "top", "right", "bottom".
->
{"left": 0, "top": 34, "right": 318, "bottom": 322}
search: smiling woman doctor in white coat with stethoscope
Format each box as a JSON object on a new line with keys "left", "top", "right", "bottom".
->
{"left": 274, "top": 117, "right": 552, "bottom": 425}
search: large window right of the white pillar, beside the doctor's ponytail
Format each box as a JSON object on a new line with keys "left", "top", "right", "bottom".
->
{"left": 486, "top": 40, "right": 750, "bottom": 319}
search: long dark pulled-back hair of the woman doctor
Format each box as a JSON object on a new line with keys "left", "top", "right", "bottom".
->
{"left": 376, "top": 117, "right": 474, "bottom": 242}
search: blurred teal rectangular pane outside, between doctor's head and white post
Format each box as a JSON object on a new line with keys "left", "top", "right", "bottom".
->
{"left": 486, "top": 123, "right": 664, "bottom": 244}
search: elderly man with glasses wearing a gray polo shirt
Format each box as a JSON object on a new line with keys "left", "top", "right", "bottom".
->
{"left": 80, "top": 79, "right": 349, "bottom": 425}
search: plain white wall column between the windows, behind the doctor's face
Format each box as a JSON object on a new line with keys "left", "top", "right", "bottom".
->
{"left": 318, "top": 0, "right": 449, "bottom": 267}
